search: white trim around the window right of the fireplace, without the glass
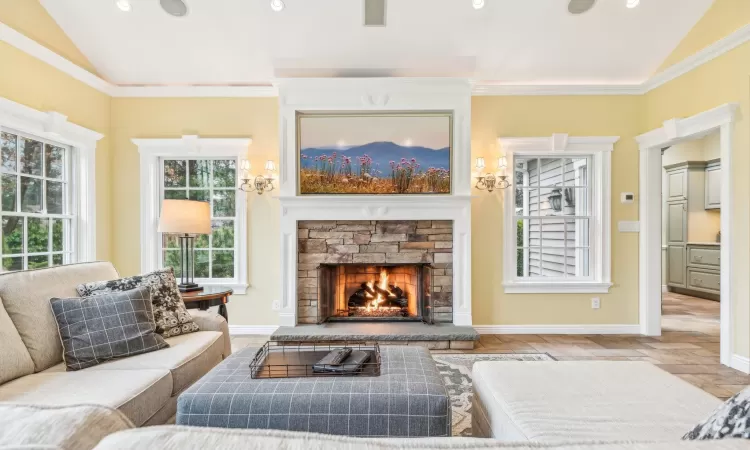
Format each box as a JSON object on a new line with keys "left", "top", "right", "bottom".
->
{"left": 498, "top": 134, "right": 620, "bottom": 294}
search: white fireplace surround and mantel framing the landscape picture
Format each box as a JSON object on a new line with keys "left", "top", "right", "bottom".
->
{"left": 278, "top": 78, "right": 472, "bottom": 326}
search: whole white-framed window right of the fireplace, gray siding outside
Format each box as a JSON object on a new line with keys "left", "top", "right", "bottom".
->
{"left": 500, "top": 135, "right": 616, "bottom": 293}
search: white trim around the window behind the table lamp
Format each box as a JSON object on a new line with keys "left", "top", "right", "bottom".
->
{"left": 132, "top": 135, "right": 253, "bottom": 295}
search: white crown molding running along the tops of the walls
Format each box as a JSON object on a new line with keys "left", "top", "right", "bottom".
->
{"left": 0, "top": 22, "right": 750, "bottom": 98}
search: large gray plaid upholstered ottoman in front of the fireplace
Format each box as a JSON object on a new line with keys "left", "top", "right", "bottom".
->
{"left": 177, "top": 346, "right": 451, "bottom": 437}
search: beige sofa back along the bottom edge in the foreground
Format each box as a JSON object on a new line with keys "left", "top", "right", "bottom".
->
{"left": 0, "top": 404, "right": 748, "bottom": 450}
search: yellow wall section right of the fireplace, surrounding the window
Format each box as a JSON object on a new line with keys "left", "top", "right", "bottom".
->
{"left": 471, "top": 96, "right": 641, "bottom": 325}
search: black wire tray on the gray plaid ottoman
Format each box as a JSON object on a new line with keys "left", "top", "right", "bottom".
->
{"left": 250, "top": 342, "right": 380, "bottom": 378}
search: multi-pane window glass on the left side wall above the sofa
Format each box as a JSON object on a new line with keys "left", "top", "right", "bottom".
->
{"left": 0, "top": 129, "right": 76, "bottom": 272}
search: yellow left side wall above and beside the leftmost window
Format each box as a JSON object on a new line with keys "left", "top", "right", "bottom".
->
{"left": 0, "top": 42, "right": 112, "bottom": 260}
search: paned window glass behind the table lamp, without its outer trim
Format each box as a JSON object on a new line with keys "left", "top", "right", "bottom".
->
{"left": 161, "top": 158, "right": 238, "bottom": 282}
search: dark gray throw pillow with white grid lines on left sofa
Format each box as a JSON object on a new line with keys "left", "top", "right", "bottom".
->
{"left": 50, "top": 287, "right": 169, "bottom": 370}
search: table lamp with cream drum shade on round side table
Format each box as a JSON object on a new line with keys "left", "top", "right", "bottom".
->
{"left": 158, "top": 200, "right": 211, "bottom": 292}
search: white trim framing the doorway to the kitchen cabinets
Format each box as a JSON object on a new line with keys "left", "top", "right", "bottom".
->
{"left": 635, "top": 103, "right": 747, "bottom": 372}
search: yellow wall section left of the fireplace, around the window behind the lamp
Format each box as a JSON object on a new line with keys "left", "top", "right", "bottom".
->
{"left": 111, "top": 98, "right": 281, "bottom": 325}
